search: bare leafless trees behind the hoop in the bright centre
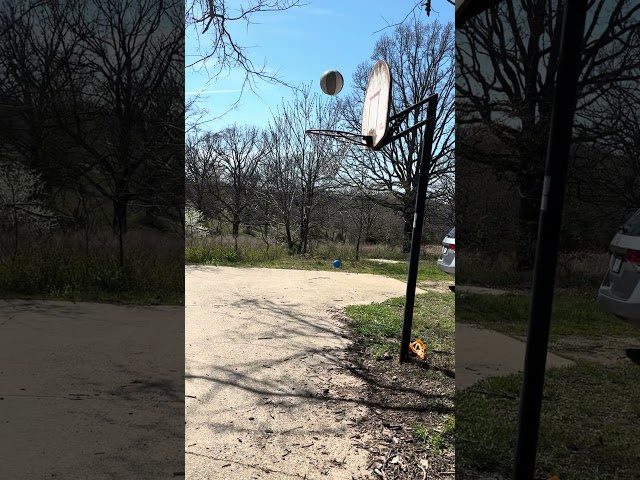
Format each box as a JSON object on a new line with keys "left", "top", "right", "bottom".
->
{"left": 185, "top": 19, "right": 455, "bottom": 256}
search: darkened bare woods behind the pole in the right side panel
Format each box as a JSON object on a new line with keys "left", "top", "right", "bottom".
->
{"left": 456, "top": 0, "right": 640, "bottom": 284}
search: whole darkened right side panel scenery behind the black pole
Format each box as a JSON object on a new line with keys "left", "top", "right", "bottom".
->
{"left": 456, "top": 0, "right": 640, "bottom": 479}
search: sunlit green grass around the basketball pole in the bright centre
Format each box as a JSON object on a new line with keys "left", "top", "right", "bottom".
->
{"left": 346, "top": 292, "right": 455, "bottom": 358}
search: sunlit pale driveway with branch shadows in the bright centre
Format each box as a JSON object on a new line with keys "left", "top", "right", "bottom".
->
{"left": 185, "top": 266, "right": 420, "bottom": 480}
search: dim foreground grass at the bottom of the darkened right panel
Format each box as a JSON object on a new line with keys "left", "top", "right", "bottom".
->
{"left": 456, "top": 361, "right": 640, "bottom": 480}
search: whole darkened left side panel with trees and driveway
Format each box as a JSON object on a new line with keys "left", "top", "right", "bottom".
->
{"left": 0, "top": 0, "right": 184, "bottom": 479}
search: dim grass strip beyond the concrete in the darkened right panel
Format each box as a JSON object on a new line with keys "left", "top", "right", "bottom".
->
{"left": 456, "top": 292, "right": 640, "bottom": 338}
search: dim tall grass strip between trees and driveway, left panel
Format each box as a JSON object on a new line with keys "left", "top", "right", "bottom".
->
{"left": 0, "top": 230, "right": 184, "bottom": 304}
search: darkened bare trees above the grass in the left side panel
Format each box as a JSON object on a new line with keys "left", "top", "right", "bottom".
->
{"left": 0, "top": 0, "right": 185, "bottom": 266}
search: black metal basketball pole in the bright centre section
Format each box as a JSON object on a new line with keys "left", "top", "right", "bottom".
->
{"left": 400, "top": 95, "right": 438, "bottom": 363}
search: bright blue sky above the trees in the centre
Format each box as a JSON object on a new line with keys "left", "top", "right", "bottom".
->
{"left": 185, "top": 0, "right": 454, "bottom": 130}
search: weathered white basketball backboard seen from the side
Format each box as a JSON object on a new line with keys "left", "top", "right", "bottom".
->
{"left": 362, "top": 60, "right": 391, "bottom": 149}
